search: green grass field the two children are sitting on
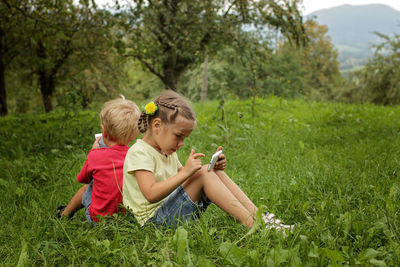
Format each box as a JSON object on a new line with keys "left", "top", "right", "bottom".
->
{"left": 0, "top": 98, "right": 400, "bottom": 266}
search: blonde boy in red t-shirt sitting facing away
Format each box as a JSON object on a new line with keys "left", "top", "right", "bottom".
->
{"left": 57, "top": 99, "right": 140, "bottom": 223}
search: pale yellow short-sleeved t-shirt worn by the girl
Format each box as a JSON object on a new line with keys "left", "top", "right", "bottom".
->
{"left": 122, "top": 139, "right": 182, "bottom": 225}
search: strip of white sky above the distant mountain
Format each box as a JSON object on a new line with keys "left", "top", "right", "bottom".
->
{"left": 303, "top": 0, "right": 400, "bottom": 15}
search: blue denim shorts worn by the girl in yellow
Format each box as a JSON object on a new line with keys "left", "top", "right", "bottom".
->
{"left": 146, "top": 185, "right": 212, "bottom": 226}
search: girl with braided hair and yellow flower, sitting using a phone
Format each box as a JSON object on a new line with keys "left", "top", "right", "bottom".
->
{"left": 123, "top": 91, "right": 291, "bottom": 230}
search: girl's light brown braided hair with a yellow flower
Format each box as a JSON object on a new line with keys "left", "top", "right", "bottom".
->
{"left": 138, "top": 90, "right": 196, "bottom": 133}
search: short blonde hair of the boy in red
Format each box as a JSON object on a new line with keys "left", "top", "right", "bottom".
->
{"left": 100, "top": 98, "right": 140, "bottom": 144}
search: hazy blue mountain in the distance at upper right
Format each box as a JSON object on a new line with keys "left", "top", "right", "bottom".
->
{"left": 307, "top": 4, "right": 400, "bottom": 71}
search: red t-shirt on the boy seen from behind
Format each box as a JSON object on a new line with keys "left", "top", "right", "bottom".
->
{"left": 77, "top": 145, "right": 129, "bottom": 221}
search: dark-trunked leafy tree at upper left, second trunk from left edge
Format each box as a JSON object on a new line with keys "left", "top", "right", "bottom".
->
{"left": 31, "top": 0, "right": 112, "bottom": 112}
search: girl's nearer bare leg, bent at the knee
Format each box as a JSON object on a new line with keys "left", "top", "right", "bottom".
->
{"left": 183, "top": 166, "right": 253, "bottom": 227}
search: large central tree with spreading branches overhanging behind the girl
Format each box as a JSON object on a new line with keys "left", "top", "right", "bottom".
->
{"left": 118, "top": 0, "right": 303, "bottom": 90}
